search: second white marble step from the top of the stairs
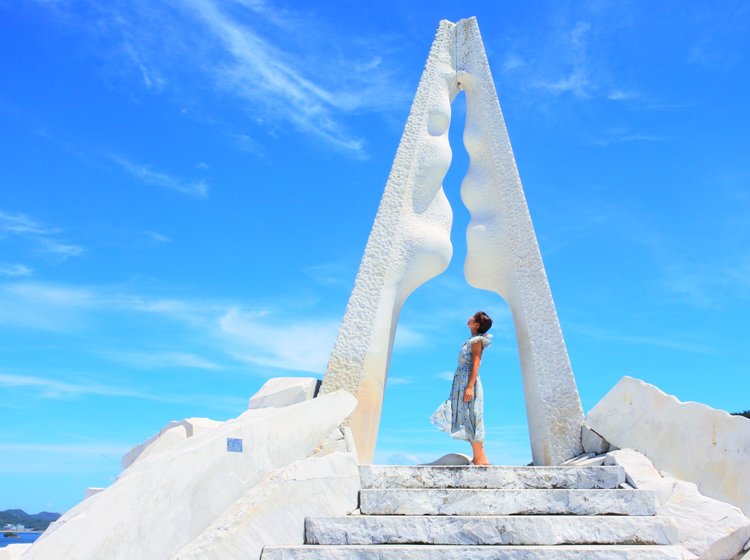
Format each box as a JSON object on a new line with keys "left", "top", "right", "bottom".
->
{"left": 359, "top": 488, "right": 656, "bottom": 515}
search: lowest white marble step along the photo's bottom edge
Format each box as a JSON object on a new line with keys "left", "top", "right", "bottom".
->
{"left": 261, "top": 545, "right": 682, "bottom": 560}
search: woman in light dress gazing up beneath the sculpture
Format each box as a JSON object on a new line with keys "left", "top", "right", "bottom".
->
{"left": 430, "top": 311, "right": 492, "bottom": 465}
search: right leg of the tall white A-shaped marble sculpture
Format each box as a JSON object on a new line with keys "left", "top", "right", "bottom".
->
{"left": 456, "top": 18, "right": 583, "bottom": 465}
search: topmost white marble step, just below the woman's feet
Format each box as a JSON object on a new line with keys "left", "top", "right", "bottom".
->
{"left": 359, "top": 465, "right": 625, "bottom": 489}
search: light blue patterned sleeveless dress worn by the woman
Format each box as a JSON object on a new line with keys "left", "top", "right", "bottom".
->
{"left": 430, "top": 333, "right": 492, "bottom": 441}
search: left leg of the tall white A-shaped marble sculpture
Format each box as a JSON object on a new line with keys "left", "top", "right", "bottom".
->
{"left": 320, "top": 20, "right": 458, "bottom": 463}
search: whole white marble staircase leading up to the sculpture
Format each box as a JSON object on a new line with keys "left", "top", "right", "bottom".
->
{"left": 261, "top": 465, "right": 682, "bottom": 560}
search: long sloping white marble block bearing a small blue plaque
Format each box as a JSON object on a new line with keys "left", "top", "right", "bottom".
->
{"left": 24, "top": 391, "right": 356, "bottom": 560}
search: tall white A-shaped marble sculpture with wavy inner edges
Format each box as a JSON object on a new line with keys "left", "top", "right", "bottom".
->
{"left": 321, "top": 18, "right": 583, "bottom": 465}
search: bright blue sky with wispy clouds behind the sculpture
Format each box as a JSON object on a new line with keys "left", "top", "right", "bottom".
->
{"left": 0, "top": 0, "right": 750, "bottom": 512}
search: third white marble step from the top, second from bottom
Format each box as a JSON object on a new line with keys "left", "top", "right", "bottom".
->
{"left": 305, "top": 515, "right": 677, "bottom": 545}
